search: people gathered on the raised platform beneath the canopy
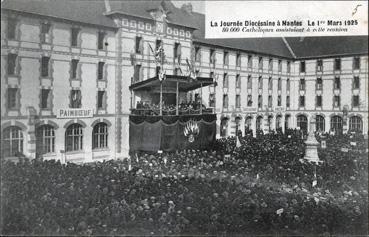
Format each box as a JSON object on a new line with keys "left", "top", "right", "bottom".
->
{"left": 132, "top": 101, "right": 212, "bottom": 115}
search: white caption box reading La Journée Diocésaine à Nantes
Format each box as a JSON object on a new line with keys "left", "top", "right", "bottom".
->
{"left": 205, "top": 1, "right": 368, "bottom": 38}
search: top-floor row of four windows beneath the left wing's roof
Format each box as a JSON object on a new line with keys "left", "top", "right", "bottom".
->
{"left": 7, "top": 17, "right": 108, "bottom": 50}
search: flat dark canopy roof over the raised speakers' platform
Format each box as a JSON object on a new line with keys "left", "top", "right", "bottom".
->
{"left": 129, "top": 75, "right": 214, "bottom": 92}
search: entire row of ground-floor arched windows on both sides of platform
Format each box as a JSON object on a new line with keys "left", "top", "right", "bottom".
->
{"left": 2, "top": 115, "right": 363, "bottom": 157}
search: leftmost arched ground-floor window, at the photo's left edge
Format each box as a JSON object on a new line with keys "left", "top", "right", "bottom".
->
{"left": 2, "top": 126, "right": 23, "bottom": 157}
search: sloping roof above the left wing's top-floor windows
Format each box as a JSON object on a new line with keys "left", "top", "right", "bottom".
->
{"left": 1, "top": 0, "right": 116, "bottom": 28}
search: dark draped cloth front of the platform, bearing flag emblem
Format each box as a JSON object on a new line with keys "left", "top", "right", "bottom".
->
{"left": 129, "top": 114, "right": 216, "bottom": 152}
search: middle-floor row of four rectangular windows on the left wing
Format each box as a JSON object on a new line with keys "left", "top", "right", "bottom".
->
{"left": 7, "top": 53, "right": 105, "bottom": 80}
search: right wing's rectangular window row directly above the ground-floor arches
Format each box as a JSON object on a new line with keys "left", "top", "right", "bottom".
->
{"left": 218, "top": 93, "right": 360, "bottom": 109}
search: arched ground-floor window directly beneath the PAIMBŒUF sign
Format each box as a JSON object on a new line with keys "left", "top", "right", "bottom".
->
{"left": 65, "top": 123, "right": 83, "bottom": 151}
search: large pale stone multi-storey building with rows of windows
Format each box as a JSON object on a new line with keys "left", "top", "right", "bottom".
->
{"left": 1, "top": 0, "right": 368, "bottom": 162}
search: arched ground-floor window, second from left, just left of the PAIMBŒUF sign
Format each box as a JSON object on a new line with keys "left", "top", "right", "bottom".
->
{"left": 36, "top": 125, "right": 55, "bottom": 155}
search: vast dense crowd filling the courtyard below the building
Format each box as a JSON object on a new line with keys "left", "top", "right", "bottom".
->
{"left": 1, "top": 130, "right": 368, "bottom": 235}
